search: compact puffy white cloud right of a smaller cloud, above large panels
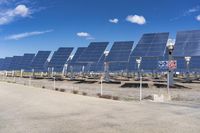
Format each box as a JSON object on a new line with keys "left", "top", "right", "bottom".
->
{"left": 126, "top": 15, "right": 146, "bottom": 25}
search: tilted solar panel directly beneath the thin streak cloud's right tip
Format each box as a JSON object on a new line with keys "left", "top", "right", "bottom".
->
{"left": 31, "top": 51, "right": 51, "bottom": 72}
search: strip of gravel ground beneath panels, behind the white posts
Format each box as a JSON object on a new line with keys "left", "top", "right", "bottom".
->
{"left": 0, "top": 77, "right": 200, "bottom": 103}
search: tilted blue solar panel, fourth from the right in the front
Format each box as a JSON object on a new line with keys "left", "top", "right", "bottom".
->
{"left": 78, "top": 42, "right": 109, "bottom": 63}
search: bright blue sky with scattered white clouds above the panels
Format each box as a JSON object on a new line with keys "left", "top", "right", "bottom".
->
{"left": 0, "top": 0, "right": 200, "bottom": 58}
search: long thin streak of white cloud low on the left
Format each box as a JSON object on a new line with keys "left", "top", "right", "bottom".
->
{"left": 5, "top": 30, "right": 53, "bottom": 40}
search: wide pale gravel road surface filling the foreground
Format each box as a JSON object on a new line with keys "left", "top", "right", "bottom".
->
{"left": 0, "top": 82, "right": 200, "bottom": 133}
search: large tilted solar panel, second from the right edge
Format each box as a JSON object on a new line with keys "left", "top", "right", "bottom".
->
{"left": 131, "top": 33, "right": 169, "bottom": 57}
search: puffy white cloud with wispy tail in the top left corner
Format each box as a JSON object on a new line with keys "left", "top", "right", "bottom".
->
{"left": 0, "top": 5, "right": 31, "bottom": 25}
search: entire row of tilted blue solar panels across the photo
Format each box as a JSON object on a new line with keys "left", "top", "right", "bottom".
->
{"left": 0, "top": 30, "right": 200, "bottom": 72}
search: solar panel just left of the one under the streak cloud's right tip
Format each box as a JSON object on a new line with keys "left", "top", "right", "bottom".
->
{"left": 19, "top": 53, "right": 35, "bottom": 71}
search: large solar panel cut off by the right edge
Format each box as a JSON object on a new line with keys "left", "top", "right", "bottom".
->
{"left": 173, "top": 30, "right": 200, "bottom": 57}
